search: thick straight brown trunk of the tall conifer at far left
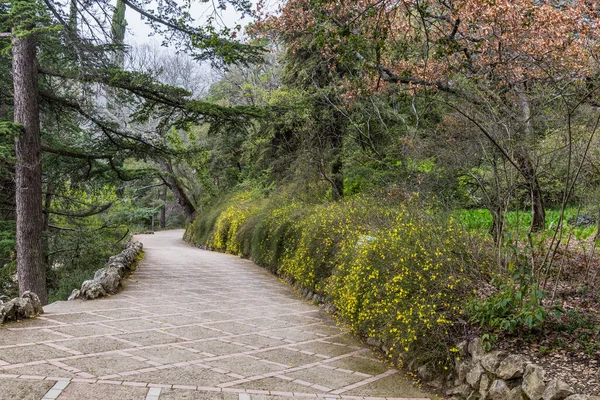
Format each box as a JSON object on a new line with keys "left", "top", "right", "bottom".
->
{"left": 13, "top": 35, "right": 48, "bottom": 304}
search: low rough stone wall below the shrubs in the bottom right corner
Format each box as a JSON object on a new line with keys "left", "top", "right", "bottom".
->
{"left": 438, "top": 338, "right": 600, "bottom": 400}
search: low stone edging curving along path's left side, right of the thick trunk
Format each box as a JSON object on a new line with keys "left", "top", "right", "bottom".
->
{"left": 69, "top": 242, "right": 143, "bottom": 300}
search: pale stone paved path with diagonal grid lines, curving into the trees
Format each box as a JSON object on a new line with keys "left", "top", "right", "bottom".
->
{"left": 0, "top": 231, "right": 432, "bottom": 400}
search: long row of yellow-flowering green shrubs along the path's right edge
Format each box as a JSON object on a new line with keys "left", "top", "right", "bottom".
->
{"left": 186, "top": 193, "right": 486, "bottom": 366}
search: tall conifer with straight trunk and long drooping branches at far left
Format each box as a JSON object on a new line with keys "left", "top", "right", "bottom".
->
{"left": 0, "top": 0, "right": 262, "bottom": 303}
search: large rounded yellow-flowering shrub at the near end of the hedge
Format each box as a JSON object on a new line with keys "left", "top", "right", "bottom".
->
{"left": 328, "top": 207, "right": 467, "bottom": 368}
